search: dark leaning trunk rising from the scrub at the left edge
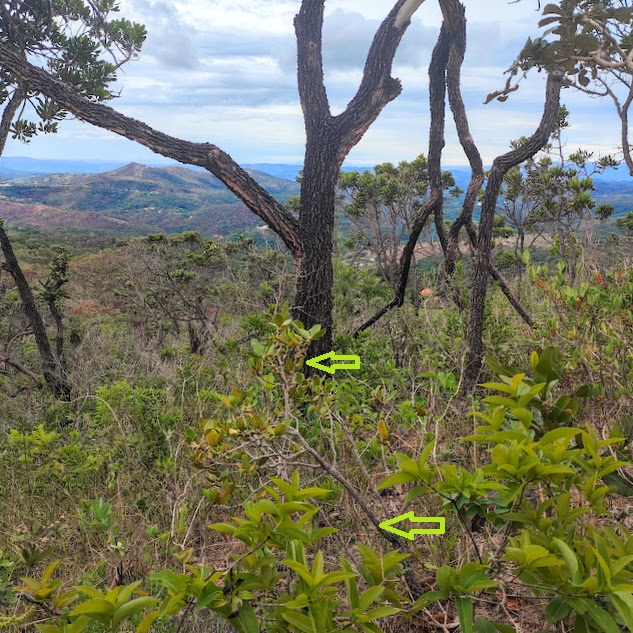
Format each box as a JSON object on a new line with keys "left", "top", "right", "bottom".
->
{"left": 0, "top": 225, "right": 71, "bottom": 400}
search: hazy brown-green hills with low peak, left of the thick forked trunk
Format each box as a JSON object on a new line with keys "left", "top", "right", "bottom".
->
{"left": 0, "top": 163, "right": 299, "bottom": 235}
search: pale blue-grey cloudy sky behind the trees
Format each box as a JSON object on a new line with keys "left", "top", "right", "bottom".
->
{"left": 5, "top": 0, "right": 618, "bottom": 166}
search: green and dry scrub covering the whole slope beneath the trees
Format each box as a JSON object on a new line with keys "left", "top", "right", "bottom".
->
{"left": 0, "top": 206, "right": 633, "bottom": 633}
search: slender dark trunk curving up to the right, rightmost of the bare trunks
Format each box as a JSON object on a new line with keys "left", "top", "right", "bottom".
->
{"left": 463, "top": 71, "right": 562, "bottom": 391}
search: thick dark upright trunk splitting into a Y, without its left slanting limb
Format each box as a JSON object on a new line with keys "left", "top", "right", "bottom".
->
{"left": 293, "top": 0, "right": 424, "bottom": 356}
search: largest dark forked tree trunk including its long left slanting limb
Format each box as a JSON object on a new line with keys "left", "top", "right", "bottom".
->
{"left": 0, "top": 0, "right": 424, "bottom": 354}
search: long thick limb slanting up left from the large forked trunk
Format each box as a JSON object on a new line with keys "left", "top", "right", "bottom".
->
{"left": 0, "top": 44, "right": 302, "bottom": 253}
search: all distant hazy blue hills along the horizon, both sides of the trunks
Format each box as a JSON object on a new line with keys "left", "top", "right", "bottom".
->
{"left": 0, "top": 158, "right": 633, "bottom": 235}
